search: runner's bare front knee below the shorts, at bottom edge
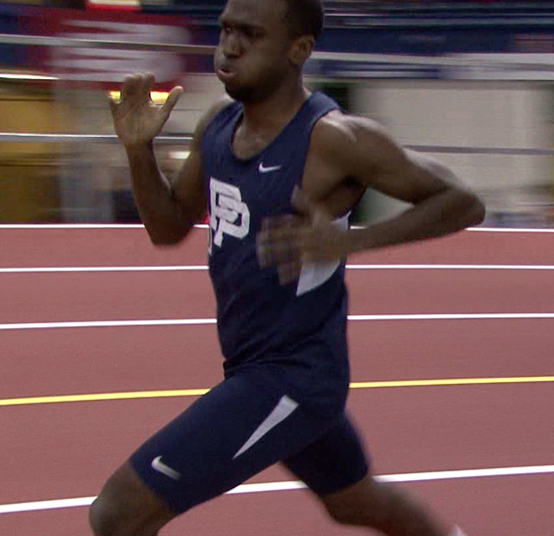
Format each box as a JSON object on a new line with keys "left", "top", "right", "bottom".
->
{"left": 89, "top": 464, "right": 175, "bottom": 536}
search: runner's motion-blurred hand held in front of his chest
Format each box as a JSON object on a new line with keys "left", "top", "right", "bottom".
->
{"left": 257, "top": 188, "right": 348, "bottom": 285}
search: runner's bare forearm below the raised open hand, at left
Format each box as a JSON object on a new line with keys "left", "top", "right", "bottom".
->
{"left": 125, "top": 143, "right": 192, "bottom": 244}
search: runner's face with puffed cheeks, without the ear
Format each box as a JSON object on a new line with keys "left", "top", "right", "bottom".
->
{"left": 214, "top": 0, "right": 293, "bottom": 102}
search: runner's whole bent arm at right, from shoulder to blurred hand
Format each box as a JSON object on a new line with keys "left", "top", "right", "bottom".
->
{"left": 258, "top": 116, "right": 484, "bottom": 276}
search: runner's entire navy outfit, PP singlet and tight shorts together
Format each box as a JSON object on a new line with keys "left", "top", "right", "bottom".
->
{"left": 130, "top": 93, "right": 368, "bottom": 513}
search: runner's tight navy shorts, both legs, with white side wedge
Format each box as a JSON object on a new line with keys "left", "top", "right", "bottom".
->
{"left": 130, "top": 350, "right": 368, "bottom": 513}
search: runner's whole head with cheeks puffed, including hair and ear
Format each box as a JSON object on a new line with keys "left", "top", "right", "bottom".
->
{"left": 214, "top": 0, "right": 323, "bottom": 102}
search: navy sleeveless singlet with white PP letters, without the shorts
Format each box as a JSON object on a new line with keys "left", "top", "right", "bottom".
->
{"left": 201, "top": 92, "right": 346, "bottom": 368}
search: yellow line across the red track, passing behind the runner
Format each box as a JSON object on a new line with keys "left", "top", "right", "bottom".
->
{"left": 0, "top": 376, "right": 554, "bottom": 406}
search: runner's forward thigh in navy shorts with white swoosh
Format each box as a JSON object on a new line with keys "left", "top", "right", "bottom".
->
{"left": 130, "top": 371, "right": 336, "bottom": 513}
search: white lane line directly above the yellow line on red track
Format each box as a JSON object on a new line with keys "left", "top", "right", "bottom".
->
{"left": 0, "top": 313, "right": 554, "bottom": 331}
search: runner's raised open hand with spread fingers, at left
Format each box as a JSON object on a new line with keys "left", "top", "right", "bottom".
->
{"left": 109, "top": 73, "right": 183, "bottom": 147}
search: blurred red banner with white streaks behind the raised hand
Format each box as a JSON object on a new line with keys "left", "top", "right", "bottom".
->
{"left": 23, "top": 8, "right": 192, "bottom": 90}
